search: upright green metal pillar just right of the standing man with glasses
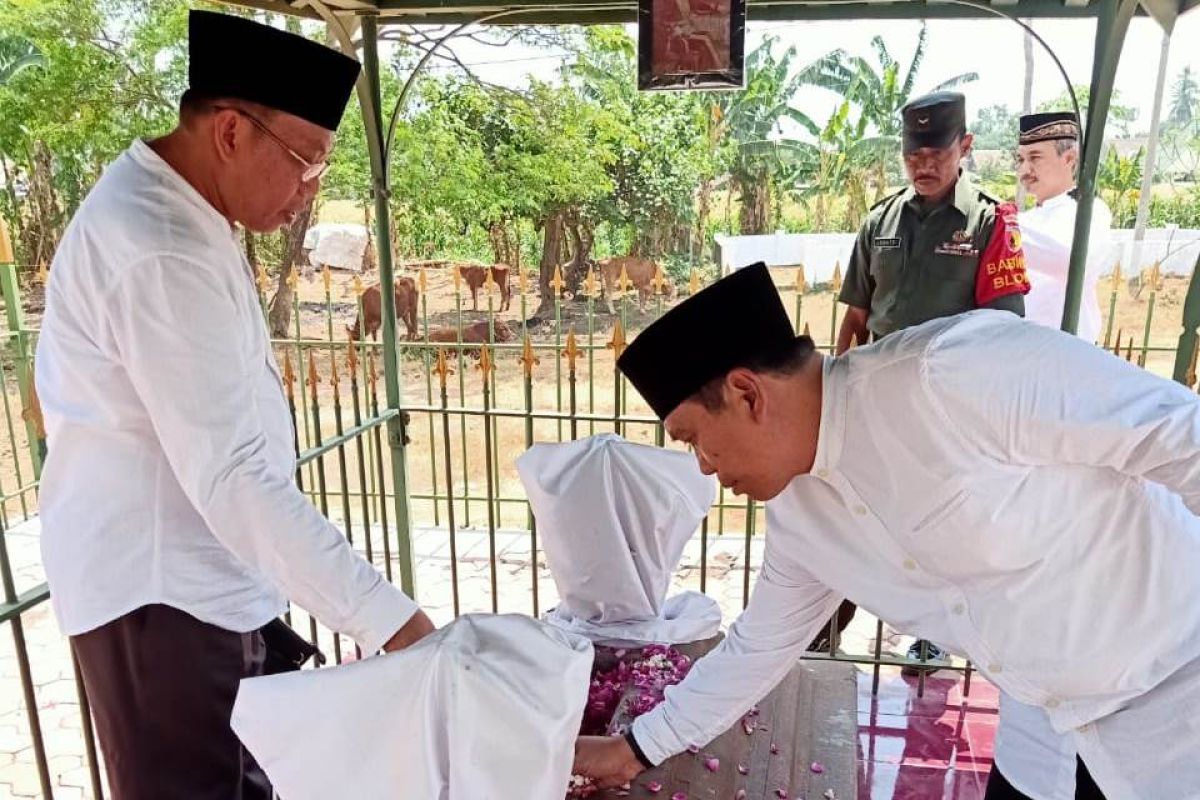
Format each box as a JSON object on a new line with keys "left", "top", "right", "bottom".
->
{"left": 359, "top": 17, "right": 416, "bottom": 596}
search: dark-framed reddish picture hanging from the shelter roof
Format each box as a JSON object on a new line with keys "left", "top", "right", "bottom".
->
{"left": 637, "top": 0, "right": 746, "bottom": 90}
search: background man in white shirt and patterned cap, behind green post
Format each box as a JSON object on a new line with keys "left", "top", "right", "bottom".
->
{"left": 1016, "top": 112, "right": 1112, "bottom": 344}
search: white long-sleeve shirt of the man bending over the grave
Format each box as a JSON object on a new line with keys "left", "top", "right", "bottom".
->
{"left": 634, "top": 311, "right": 1200, "bottom": 762}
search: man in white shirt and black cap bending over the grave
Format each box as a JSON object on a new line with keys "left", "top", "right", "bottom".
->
{"left": 576, "top": 264, "right": 1200, "bottom": 800}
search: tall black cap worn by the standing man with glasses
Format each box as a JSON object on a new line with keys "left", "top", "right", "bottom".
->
{"left": 187, "top": 11, "right": 360, "bottom": 131}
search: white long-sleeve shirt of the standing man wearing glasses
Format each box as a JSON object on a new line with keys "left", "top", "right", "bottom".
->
{"left": 36, "top": 142, "right": 416, "bottom": 652}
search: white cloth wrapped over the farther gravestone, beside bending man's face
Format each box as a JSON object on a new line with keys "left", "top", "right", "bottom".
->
{"left": 517, "top": 433, "right": 721, "bottom": 646}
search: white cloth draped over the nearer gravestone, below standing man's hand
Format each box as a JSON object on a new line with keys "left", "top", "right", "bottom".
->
{"left": 232, "top": 614, "right": 592, "bottom": 800}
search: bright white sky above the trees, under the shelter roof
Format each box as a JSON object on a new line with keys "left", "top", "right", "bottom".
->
{"left": 405, "top": 10, "right": 1200, "bottom": 133}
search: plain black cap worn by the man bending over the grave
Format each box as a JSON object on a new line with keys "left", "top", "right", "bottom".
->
{"left": 617, "top": 261, "right": 796, "bottom": 419}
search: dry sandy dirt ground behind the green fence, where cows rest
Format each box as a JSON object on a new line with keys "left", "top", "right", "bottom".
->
{"left": 0, "top": 269, "right": 1187, "bottom": 531}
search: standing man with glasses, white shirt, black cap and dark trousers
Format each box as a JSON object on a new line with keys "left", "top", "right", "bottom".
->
{"left": 37, "top": 11, "right": 432, "bottom": 800}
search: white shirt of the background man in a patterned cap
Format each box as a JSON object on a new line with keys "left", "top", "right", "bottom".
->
{"left": 1018, "top": 193, "right": 1112, "bottom": 344}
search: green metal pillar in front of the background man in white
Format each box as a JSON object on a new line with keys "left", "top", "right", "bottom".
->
{"left": 1062, "top": 0, "right": 1138, "bottom": 333}
